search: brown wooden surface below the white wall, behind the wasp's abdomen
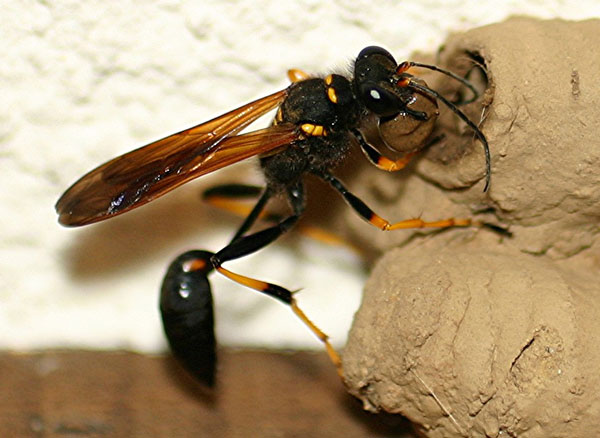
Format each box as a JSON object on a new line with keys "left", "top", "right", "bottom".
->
{"left": 0, "top": 350, "right": 410, "bottom": 438}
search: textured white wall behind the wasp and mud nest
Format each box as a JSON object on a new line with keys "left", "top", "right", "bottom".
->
{"left": 0, "top": 0, "right": 600, "bottom": 351}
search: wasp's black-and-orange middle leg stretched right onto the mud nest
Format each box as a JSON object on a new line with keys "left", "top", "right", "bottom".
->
{"left": 320, "top": 174, "right": 472, "bottom": 231}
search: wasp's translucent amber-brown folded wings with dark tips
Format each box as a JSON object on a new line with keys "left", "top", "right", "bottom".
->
{"left": 56, "top": 90, "right": 298, "bottom": 226}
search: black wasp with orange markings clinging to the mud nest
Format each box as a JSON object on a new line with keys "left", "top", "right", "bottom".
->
{"left": 56, "top": 46, "right": 491, "bottom": 383}
